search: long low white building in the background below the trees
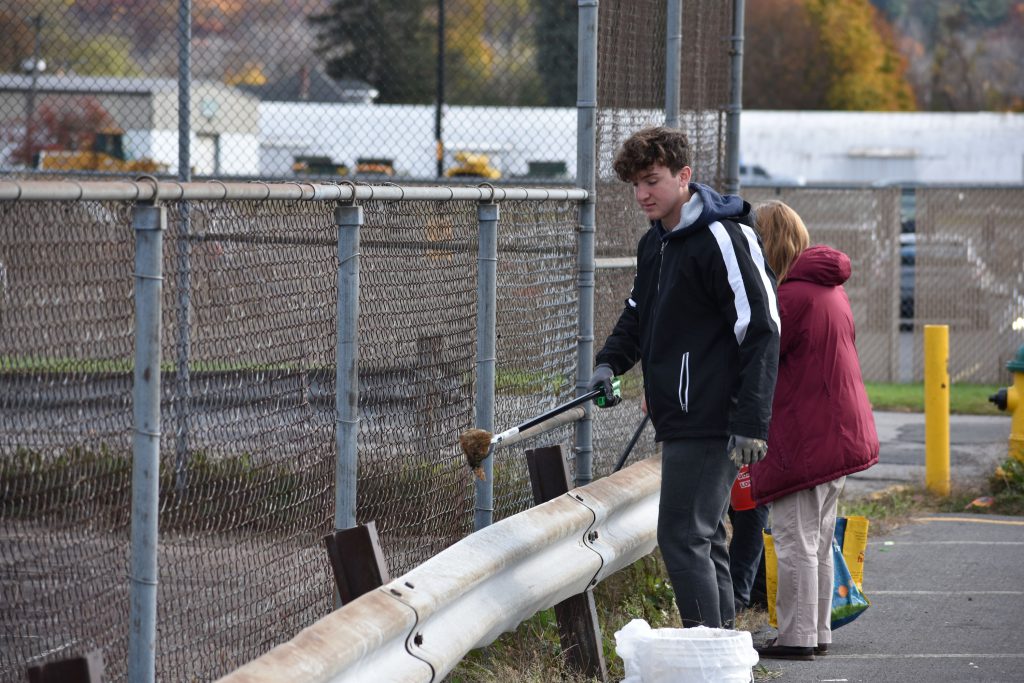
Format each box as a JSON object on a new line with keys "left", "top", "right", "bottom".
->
{"left": 260, "top": 102, "right": 1024, "bottom": 184}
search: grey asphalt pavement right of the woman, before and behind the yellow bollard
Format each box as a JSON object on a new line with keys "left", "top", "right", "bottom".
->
{"left": 755, "top": 413, "right": 1024, "bottom": 683}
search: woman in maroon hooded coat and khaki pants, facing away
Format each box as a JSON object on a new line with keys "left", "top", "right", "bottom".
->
{"left": 751, "top": 201, "right": 879, "bottom": 659}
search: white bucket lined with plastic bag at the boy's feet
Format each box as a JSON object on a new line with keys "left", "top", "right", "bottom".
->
{"left": 615, "top": 620, "right": 758, "bottom": 683}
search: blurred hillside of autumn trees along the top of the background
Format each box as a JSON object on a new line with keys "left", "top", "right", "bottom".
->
{"left": 0, "top": 0, "right": 1024, "bottom": 111}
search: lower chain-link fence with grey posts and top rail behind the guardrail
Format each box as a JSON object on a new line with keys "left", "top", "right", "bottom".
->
{"left": 0, "top": 180, "right": 650, "bottom": 680}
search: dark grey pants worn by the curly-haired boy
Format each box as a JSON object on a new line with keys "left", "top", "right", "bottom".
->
{"left": 657, "top": 438, "right": 737, "bottom": 628}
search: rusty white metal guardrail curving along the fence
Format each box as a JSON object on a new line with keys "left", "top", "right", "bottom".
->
{"left": 220, "top": 458, "right": 662, "bottom": 683}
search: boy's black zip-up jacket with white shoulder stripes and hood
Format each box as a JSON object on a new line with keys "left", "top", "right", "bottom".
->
{"left": 596, "top": 183, "right": 779, "bottom": 441}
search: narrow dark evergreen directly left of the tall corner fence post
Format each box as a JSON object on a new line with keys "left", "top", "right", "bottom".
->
{"left": 534, "top": 0, "right": 579, "bottom": 106}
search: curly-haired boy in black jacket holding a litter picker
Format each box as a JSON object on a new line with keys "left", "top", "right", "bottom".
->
{"left": 590, "top": 127, "right": 779, "bottom": 628}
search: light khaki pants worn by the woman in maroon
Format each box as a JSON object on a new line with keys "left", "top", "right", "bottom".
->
{"left": 771, "top": 477, "right": 846, "bottom": 647}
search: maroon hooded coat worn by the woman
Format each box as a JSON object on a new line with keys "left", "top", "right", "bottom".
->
{"left": 751, "top": 246, "right": 879, "bottom": 505}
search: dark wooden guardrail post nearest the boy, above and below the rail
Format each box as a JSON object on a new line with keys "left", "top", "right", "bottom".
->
{"left": 526, "top": 445, "right": 608, "bottom": 681}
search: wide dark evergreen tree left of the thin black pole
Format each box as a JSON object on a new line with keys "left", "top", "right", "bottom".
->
{"left": 309, "top": 0, "right": 437, "bottom": 103}
